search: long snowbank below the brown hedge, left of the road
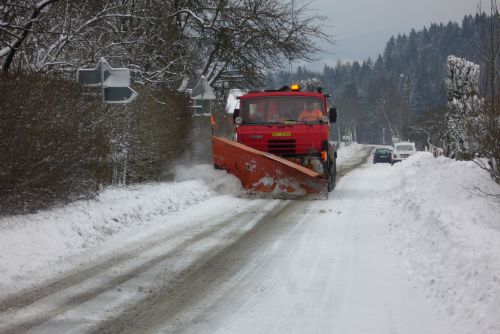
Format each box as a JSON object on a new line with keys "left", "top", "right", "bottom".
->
{"left": 0, "top": 166, "right": 237, "bottom": 288}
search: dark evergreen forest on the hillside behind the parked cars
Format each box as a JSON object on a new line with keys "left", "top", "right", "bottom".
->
{"left": 268, "top": 12, "right": 499, "bottom": 149}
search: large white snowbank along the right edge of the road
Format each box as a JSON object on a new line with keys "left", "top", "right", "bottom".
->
{"left": 388, "top": 153, "right": 500, "bottom": 334}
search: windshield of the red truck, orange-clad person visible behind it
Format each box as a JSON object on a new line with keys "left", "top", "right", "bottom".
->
{"left": 240, "top": 96, "right": 325, "bottom": 124}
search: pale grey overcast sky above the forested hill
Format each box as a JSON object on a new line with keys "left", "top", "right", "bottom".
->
{"left": 306, "top": 0, "right": 489, "bottom": 69}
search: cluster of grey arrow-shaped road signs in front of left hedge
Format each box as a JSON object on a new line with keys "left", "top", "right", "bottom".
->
{"left": 76, "top": 58, "right": 137, "bottom": 103}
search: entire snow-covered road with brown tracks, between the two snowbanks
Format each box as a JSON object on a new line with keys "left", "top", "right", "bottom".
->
{"left": 0, "top": 147, "right": 500, "bottom": 334}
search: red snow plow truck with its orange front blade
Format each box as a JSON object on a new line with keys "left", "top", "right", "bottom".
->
{"left": 212, "top": 85, "right": 337, "bottom": 198}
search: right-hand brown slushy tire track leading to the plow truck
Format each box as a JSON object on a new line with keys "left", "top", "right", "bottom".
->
{"left": 90, "top": 201, "right": 309, "bottom": 334}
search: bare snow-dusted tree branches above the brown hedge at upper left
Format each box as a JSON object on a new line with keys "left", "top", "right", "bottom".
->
{"left": 0, "top": 0, "right": 328, "bottom": 90}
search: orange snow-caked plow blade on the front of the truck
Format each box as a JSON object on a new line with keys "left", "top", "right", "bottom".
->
{"left": 212, "top": 136, "right": 328, "bottom": 198}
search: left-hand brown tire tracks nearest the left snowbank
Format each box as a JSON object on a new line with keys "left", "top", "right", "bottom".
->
{"left": 0, "top": 203, "right": 282, "bottom": 333}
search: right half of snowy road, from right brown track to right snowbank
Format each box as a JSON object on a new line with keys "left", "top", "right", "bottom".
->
{"left": 93, "top": 166, "right": 450, "bottom": 334}
